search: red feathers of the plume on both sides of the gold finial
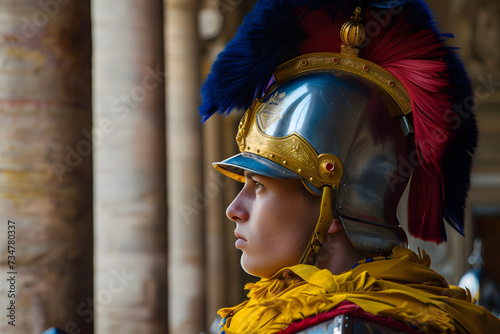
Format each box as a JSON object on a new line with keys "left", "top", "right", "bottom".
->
{"left": 299, "top": 1, "right": 476, "bottom": 243}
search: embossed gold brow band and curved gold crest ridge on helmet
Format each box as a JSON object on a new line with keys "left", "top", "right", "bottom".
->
{"left": 232, "top": 52, "right": 411, "bottom": 193}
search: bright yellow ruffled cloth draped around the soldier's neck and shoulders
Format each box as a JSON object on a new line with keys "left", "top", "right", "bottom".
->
{"left": 218, "top": 247, "right": 500, "bottom": 334}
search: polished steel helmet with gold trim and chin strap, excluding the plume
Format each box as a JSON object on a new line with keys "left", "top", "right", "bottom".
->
{"left": 214, "top": 53, "right": 409, "bottom": 263}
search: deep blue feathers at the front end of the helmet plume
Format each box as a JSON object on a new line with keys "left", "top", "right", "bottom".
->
{"left": 199, "top": 0, "right": 329, "bottom": 121}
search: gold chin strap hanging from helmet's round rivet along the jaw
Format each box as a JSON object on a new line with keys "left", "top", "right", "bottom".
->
{"left": 299, "top": 186, "right": 333, "bottom": 265}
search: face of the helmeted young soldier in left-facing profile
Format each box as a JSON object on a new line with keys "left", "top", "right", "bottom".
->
{"left": 226, "top": 172, "right": 321, "bottom": 277}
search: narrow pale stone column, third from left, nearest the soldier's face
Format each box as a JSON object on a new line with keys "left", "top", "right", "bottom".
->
{"left": 164, "top": 0, "right": 207, "bottom": 333}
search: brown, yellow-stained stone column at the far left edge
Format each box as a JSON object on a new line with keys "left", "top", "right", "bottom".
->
{"left": 0, "top": 0, "right": 93, "bottom": 333}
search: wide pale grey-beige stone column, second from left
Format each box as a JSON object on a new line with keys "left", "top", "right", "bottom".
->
{"left": 92, "top": 0, "right": 167, "bottom": 334}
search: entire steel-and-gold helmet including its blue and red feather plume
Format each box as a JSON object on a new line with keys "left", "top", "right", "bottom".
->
{"left": 200, "top": 1, "right": 477, "bottom": 263}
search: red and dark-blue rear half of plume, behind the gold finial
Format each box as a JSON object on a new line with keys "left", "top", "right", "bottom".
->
{"left": 360, "top": 1, "right": 477, "bottom": 243}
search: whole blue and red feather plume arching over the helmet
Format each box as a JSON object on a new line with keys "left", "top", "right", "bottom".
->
{"left": 200, "top": 0, "right": 478, "bottom": 243}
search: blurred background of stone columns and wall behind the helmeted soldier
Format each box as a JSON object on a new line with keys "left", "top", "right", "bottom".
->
{"left": 0, "top": 0, "right": 500, "bottom": 334}
